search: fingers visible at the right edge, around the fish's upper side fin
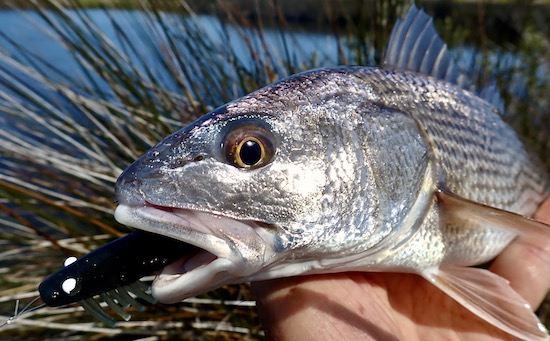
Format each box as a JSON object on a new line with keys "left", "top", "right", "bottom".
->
{"left": 490, "top": 199, "right": 550, "bottom": 309}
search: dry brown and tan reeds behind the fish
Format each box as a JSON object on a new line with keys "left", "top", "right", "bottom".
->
{"left": 0, "top": 0, "right": 550, "bottom": 340}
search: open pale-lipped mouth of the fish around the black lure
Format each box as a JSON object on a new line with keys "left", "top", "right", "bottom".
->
{"left": 115, "top": 203, "right": 275, "bottom": 303}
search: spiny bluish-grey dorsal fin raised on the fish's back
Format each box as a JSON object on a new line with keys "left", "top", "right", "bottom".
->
{"left": 382, "top": 3, "right": 503, "bottom": 110}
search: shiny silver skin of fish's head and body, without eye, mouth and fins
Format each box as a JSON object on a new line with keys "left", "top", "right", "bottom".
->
{"left": 118, "top": 67, "right": 547, "bottom": 267}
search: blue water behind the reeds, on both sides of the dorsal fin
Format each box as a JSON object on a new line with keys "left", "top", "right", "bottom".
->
{"left": 0, "top": 9, "right": 549, "bottom": 159}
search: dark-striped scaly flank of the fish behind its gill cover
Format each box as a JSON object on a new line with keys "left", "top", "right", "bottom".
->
{"left": 365, "top": 69, "right": 548, "bottom": 211}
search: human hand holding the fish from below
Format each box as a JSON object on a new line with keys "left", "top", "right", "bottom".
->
{"left": 252, "top": 199, "right": 550, "bottom": 341}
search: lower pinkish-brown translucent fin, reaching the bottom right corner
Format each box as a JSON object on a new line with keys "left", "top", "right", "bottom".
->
{"left": 421, "top": 267, "right": 549, "bottom": 340}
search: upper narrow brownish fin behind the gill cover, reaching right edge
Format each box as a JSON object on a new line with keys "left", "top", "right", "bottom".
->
{"left": 436, "top": 189, "right": 550, "bottom": 240}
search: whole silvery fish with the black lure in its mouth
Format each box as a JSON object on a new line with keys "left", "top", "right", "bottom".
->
{"left": 40, "top": 3, "right": 550, "bottom": 340}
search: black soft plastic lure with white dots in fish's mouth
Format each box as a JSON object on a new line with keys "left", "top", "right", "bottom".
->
{"left": 38, "top": 231, "right": 191, "bottom": 325}
